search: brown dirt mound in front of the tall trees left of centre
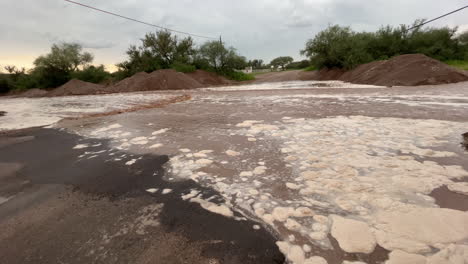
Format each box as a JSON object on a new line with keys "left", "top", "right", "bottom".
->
{"left": 109, "top": 70, "right": 203, "bottom": 92}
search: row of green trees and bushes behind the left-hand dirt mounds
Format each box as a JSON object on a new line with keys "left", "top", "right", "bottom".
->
{"left": 0, "top": 31, "right": 252, "bottom": 93}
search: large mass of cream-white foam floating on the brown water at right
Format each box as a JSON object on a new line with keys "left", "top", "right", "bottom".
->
{"left": 166, "top": 116, "right": 468, "bottom": 263}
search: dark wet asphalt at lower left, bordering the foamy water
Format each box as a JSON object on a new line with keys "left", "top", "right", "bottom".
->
{"left": 0, "top": 129, "right": 284, "bottom": 263}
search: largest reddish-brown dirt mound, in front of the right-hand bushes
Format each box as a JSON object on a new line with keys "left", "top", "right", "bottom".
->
{"left": 316, "top": 54, "right": 468, "bottom": 86}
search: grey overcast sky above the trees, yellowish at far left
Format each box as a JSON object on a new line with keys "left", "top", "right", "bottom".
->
{"left": 0, "top": 0, "right": 468, "bottom": 71}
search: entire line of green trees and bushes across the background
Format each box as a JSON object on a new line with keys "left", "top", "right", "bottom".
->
{"left": 0, "top": 20, "right": 468, "bottom": 93}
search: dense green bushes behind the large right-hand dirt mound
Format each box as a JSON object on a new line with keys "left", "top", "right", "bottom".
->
{"left": 301, "top": 20, "right": 468, "bottom": 69}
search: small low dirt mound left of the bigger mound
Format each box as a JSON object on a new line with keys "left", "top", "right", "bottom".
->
{"left": 47, "top": 79, "right": 105, "bottom": 96}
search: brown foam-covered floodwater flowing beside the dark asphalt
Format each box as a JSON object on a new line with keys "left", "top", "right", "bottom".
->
{"left": 2, "top": 83, "right": 468, "bottom": 263}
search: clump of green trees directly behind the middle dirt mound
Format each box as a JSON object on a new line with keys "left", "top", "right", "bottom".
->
{"left": 116, "top": 31, "right": 249, "bottom": 80}
